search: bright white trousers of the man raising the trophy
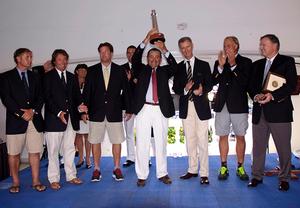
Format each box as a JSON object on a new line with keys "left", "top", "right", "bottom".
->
{"left": 135, "top": 104, "right": 168, "bottom": 180}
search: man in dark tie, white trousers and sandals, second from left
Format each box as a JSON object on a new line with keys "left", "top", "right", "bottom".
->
{"left": 44, "top": 49, "right": 87, "bottom": 190}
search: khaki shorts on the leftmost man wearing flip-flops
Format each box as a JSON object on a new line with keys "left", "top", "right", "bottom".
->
{"left": 6, "top": 121, "right": 43, "bottom": 155}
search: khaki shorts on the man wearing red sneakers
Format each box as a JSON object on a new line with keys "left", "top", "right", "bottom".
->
{"left": 88, "top": 119, "right": 125, "bottom": 144}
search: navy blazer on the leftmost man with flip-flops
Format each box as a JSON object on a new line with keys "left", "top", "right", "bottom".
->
{"left": 1, "top": 68, "right": 44, "bottom": 134}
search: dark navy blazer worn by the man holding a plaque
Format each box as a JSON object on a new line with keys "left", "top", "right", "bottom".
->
{"left": 249, "top": 54, "right": 297, "bottom": 124}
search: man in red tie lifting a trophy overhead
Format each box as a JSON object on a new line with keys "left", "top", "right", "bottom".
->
{"left": 132, "top": 10, "right": 176, "bottom": 187}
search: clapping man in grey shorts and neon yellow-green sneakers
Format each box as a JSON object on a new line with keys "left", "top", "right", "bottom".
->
{"left": 213, "top": 36, "right": 252, "bottom": 181}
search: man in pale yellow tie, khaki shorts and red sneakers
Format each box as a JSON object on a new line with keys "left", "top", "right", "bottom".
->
{"left": 83, "top": 42, "right": 132, "bottom": 182}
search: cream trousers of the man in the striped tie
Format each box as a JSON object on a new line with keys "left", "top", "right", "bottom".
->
{"left": 182, "top": 101, "right": 209, "bottom": 177}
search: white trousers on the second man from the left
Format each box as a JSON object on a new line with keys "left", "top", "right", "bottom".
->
{"left": 45, "top": 118, "right": 77, "bottom": 183}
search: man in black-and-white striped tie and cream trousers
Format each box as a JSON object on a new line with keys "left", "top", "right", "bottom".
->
{"left": 173, "top": 37, "right": 212, "bottom": 184}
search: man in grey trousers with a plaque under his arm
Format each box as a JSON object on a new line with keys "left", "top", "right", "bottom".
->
{"left": 248, "top": 34, "right": 297, "bottom": 191}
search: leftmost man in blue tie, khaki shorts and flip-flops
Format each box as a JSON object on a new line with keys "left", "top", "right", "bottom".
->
{"left": 1, "top": 48, "right": 46, "bottom": 193}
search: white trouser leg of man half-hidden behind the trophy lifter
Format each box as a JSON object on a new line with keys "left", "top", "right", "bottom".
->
{"left": 124, "top": 115, "right": 135, "bottom": 162}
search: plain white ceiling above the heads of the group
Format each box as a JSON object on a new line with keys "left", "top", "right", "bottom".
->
{"left": 0, "top": 0, "right": 300, "bottom": 71}
